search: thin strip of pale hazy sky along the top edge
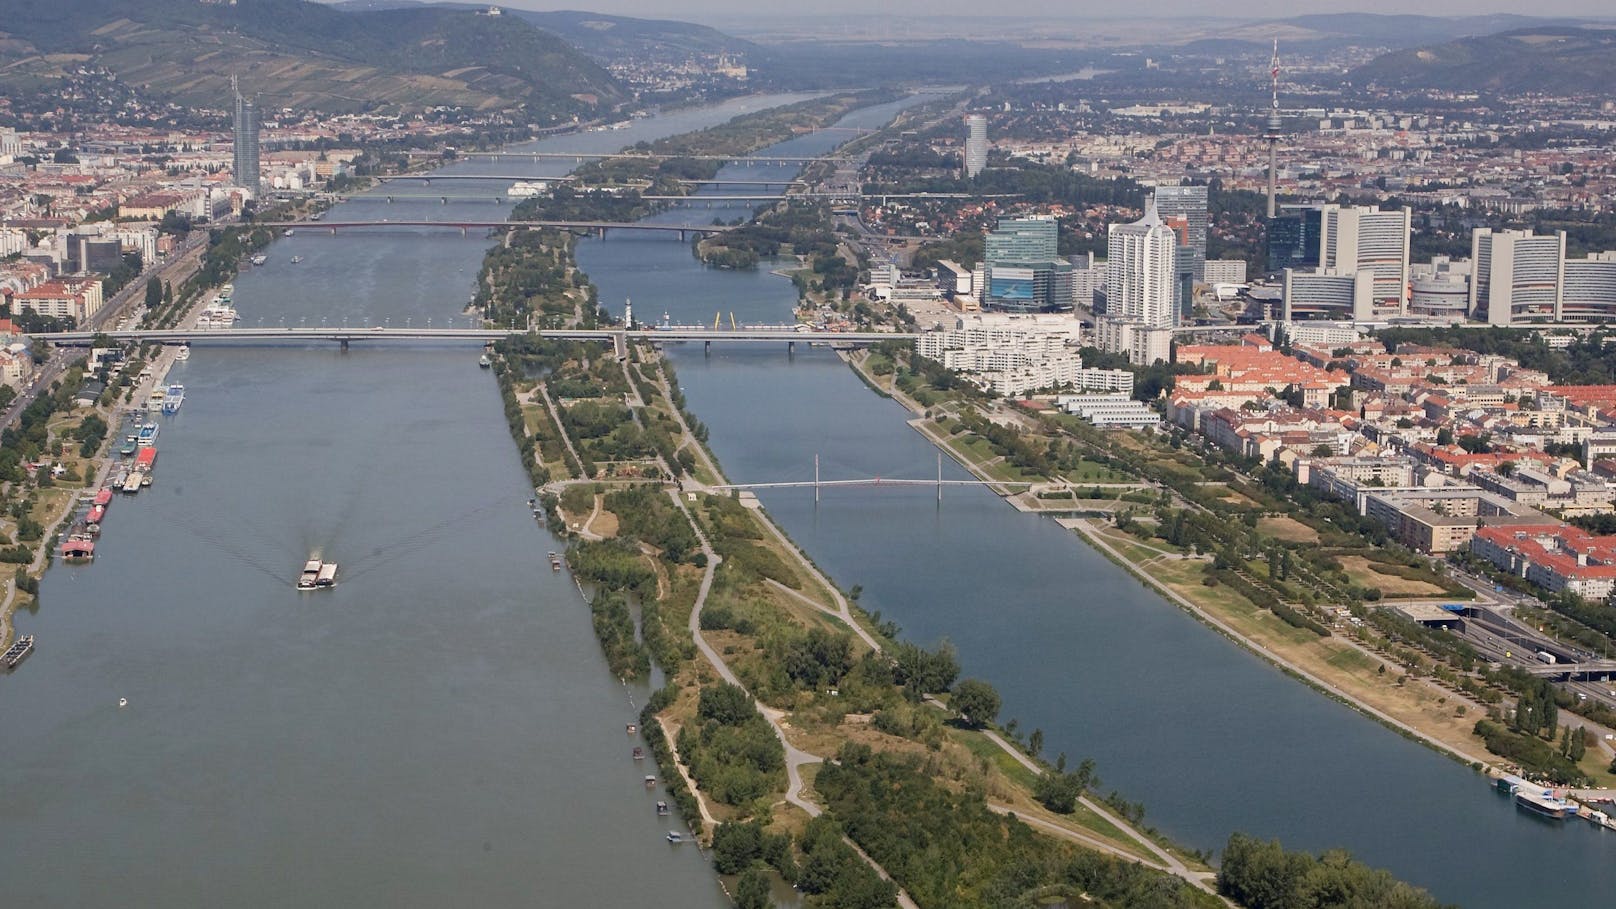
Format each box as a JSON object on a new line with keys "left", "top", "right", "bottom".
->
{"left": 471, "top": 0, "right": 1616, "bottom": 23}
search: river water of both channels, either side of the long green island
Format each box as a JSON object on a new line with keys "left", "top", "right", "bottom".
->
{"left": 0, "top": 99, "right": 1616, "bottom": 907}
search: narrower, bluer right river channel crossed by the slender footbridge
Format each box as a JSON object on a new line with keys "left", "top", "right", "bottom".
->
{"left": 579, "top": 100, "right": 1616, "bottom": 907}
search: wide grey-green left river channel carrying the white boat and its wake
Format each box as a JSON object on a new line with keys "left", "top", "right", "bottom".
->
{"left": 0, "top": 99, "right": 814, "bottom": 909}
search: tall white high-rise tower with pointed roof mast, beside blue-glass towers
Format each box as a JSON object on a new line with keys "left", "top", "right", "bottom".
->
{"left": 1099, "top": 197, "right": 1178, "bottom": 366}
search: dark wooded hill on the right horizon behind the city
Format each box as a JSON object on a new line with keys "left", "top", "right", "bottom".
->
{"left": 1349, "top": 27, "right": 1616, "bottom": 94}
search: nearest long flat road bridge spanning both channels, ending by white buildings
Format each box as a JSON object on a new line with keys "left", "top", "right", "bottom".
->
{"left": 31, "top": 325, "right": 920, "bottom": 349}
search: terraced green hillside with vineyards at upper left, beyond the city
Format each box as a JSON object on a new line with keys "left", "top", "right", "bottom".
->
{"left": 0, "top": 0, "right": 624, "bottom": 121}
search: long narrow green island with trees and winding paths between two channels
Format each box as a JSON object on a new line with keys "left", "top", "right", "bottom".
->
{"left": 458, "top": 93, "right": 1467, "bottom": 909}
